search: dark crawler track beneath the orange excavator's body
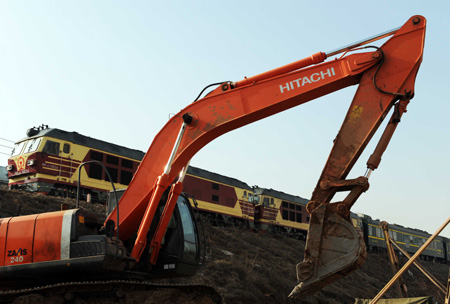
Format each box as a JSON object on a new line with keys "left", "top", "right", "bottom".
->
{"left": 0, "top": 280, "right": 223, "bottom": 304}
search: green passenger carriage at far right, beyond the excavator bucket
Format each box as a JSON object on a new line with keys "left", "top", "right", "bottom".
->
{"left": 360, "top": 215, "right": 448, "bottom": 261}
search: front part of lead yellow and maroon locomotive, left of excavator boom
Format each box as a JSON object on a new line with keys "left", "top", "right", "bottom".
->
{"left": 7, "top": 126, "right": 144, "bottom": 202}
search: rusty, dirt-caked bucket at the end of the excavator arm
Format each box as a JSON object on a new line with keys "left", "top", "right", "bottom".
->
{"left": 289, "top": 204, "right": 367, "bottom": 298}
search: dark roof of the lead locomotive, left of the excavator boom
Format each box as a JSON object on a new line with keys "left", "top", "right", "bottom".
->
{"left": 19, "top": 128, "right": 145, "bottom": 161}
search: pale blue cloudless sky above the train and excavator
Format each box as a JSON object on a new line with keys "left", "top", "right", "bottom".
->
{"left": 0, "top": 0, "right": 450, "bottom": 236}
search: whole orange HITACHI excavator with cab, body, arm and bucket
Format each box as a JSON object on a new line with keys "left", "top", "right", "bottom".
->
{"left": 0, "top": 16, "right": 426, "bottom": 297}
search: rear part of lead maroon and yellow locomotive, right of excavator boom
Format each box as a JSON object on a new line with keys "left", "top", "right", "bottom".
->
{"left": 183, "top": 166, "right": 255, "bottom": 227}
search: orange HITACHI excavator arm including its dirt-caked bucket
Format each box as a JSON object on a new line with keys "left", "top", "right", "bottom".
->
{"left": 107, "top": 16, "right": 426, "bottom": 297}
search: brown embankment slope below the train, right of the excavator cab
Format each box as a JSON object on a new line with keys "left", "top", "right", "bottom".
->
{"left": 186, "top": 223, "right": 449, "bottom": 303}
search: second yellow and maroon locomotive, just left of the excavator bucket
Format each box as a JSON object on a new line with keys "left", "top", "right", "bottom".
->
{"left": 253, "top": 187, "right": 309, "bottom": 239}
